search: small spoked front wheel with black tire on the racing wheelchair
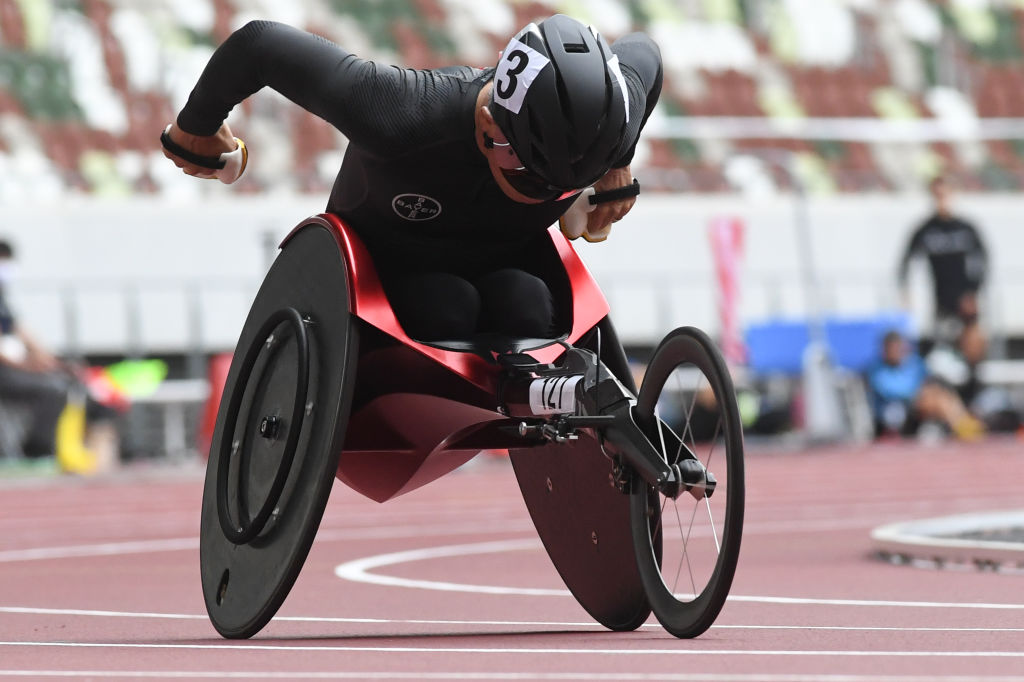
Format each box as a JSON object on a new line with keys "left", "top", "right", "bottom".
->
{"left": 630, "top": 327, "right": 744, "bottom": 637}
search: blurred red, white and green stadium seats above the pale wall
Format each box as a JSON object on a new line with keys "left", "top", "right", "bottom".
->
{"left": 0, "top": 0, "right": 1024, "bottom": 199}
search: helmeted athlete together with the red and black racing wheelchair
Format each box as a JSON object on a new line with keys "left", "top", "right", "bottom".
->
{"left": 161, "top": 15, "right": 743, "bottom": 637}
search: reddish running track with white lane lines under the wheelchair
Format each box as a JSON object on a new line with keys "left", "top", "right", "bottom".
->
{"left": 0, "top": 441, "right": 1024, "bottom": 682}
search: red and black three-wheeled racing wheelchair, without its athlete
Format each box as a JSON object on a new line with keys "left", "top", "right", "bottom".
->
{"left": 201, "top": 214, "right": 744, "bottom": 638}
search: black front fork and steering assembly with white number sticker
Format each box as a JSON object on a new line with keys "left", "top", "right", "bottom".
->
{"left": 501, "top": 348, "right": 716, "bottom": 500}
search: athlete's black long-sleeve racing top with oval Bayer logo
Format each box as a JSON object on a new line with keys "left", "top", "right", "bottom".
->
{"left": 177, "top": 22, "right": 662, "bottom": 337}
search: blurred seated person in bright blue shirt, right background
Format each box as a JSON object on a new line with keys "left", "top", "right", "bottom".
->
{"left": 867, "top": 331, "right": 985, "bottom": 439}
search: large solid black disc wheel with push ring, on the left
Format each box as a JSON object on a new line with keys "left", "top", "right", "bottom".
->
{"left": 200, "top": 225, "right": 358, "bottom": 639}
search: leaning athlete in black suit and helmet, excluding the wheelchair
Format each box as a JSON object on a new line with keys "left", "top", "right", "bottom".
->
{"left": 156, "top": 14, "right": 663, "bottom": 342}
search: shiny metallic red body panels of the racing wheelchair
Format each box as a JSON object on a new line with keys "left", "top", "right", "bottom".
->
{"left": 282, "top": 214, "right": 608, "bottom": 502}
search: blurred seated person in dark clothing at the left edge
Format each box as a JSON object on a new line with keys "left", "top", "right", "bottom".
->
{"left": 0, "top": 240, "right": 119, "bottom": 466}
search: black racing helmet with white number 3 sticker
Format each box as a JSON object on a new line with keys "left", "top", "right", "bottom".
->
{"left": 489, "top": 14, "right": 629, "bottom": 189}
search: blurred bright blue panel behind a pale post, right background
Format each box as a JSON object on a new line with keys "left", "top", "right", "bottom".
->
{"left": 745, "top": 312, "right": 915, "bottom": 375}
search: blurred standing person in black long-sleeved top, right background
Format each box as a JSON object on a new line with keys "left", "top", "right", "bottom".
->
{"left": 898, "top": 175, "right": 988, "bottom": 344}
